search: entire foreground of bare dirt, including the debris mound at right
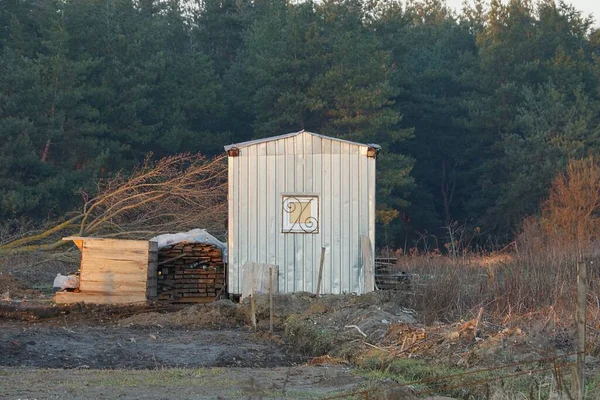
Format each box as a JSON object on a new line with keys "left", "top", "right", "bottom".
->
{"left": 0, "top": 268, "right": 600, "bottom": 400}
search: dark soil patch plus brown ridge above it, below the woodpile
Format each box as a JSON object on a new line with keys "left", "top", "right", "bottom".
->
{"left": 0, "top": 301, "right": 306, "bottom": 369}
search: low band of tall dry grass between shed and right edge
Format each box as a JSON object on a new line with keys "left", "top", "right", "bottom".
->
{"left": 398, "top": 234, "right": 600, "bottom": 329}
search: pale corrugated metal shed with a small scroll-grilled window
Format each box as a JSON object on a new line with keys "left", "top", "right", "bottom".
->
{"left": 225, "top": 131, "right": 379, "bottom": 294}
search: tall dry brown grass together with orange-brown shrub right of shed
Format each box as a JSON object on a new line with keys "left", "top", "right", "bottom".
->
{"left": 401, "top": 157, "right": 600, "bottom": 327}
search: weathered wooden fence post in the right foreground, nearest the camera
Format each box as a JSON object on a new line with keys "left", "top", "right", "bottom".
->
{"left": 576, "top": 261, "right": 587, "bottom": 400}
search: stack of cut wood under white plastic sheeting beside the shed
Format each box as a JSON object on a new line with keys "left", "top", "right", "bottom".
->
{"left": 157, "top": 242, "right": 225, "bottom": 303}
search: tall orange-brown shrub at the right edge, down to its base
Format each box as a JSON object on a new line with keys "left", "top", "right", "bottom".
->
{"left": 485, "top": 157, "right": 600, "bottom": 323}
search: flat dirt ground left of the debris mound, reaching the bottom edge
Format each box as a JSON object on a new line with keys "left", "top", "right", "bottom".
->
{"left": 0, "top": 301, "right": 365, "bottom": 399}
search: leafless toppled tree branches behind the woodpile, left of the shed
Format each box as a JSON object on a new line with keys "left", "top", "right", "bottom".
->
{"left": 0, "top": 154, "right": 227, "bottom": 254}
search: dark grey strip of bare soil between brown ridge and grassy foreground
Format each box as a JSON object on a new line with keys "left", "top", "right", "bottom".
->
{"left": 0, "top": 326, "right": 306, "bottom": 369}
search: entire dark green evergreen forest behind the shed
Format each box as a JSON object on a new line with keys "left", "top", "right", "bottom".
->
{"left": 0, "top": 0, "right": 600, "bottom": 247}
